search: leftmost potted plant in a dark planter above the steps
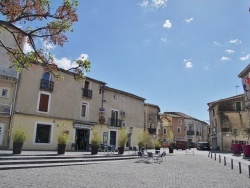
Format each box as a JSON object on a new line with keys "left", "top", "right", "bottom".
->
{"left": 11, "top": 126, "right": 27, "bottom": 154}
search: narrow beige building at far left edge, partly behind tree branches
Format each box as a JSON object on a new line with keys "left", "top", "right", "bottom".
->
{"left": 0, "top": 24, "right": 22, "bottom": 149}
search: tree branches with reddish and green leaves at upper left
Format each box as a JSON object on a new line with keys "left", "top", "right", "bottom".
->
{"left": 0, "top": 0, "right": 90, "bottom": 80}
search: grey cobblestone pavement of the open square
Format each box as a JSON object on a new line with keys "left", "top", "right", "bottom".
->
{"left": 0, "top": 150, "right": 250, "bottom": 188}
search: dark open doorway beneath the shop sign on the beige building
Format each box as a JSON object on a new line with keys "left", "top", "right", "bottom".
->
{"left": 75, "top": 129, "right": 89, "bottom": 151}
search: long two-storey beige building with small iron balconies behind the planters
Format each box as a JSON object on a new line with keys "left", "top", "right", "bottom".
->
{"left": 10, "top": 66, "right": 145, "bottom": 150}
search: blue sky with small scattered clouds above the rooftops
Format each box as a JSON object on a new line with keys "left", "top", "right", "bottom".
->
{"left": 22, "top": 0, "right": 250, "bottom": 121}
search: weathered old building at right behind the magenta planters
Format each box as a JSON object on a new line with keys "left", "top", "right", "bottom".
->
{"left": 208, "top": 94, "right": 246, "bottom": 151}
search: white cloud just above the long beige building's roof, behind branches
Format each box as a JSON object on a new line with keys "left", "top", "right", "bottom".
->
{"left": 54, "top": 54, "right": 88, "bottom": 70}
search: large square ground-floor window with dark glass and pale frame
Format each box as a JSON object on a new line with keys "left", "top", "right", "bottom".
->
{"left": 35, "top": 123, "right": 52, "bottom": 144}
